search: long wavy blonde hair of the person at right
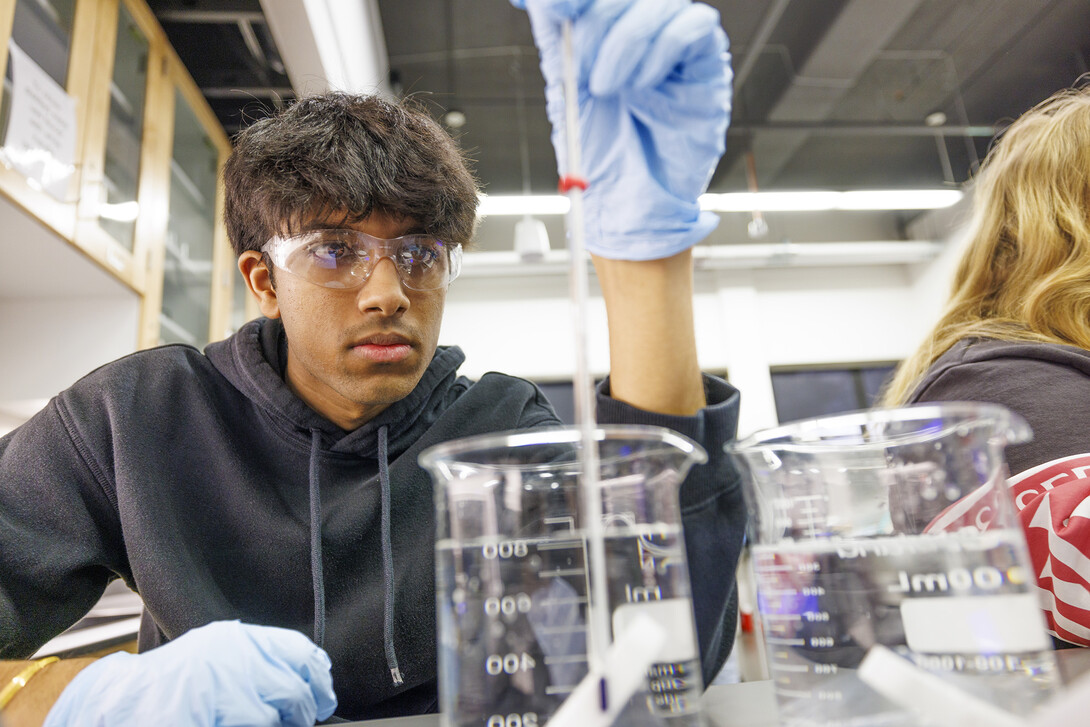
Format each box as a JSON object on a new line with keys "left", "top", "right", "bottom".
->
{"left": 881, "top": 87, "right": 1090, "bottom": 405}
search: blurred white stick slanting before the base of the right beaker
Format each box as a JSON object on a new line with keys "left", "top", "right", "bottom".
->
{"left": 858, "top": 644, "right": 1029, "bottom": 727}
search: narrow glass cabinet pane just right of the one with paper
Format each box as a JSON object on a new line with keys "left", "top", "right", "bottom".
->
{"left": 97, "top": 3, "right": 148, "bottom": 251}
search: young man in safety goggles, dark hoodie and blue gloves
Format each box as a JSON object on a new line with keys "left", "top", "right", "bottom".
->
{"left": 0, "top": 0, "right": 743, "bottom": 727}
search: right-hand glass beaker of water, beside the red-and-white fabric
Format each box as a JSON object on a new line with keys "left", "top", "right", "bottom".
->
{"left": 726, "top": 402, "right": 1058, "bottom": 727}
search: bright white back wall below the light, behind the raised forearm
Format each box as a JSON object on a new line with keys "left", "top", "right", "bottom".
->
{"left": 440, "top": 201, "right": 976, "bottom": 435}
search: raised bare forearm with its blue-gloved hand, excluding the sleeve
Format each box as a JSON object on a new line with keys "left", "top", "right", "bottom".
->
{"left": 516, "top": 0, "right": 731, "bottom": 415}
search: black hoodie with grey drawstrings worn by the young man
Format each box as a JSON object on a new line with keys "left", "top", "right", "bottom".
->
{"left": 0, "top": 320, "right": 743, "bottom": 719}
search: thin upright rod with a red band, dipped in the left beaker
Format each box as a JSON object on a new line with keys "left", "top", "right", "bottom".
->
{"left": 561, "top": 21, "right": 610, "bottom": 713}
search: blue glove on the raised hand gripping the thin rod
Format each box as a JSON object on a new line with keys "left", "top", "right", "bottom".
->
{"left": 511, "top": 0, "right": 732, "bottom": 259}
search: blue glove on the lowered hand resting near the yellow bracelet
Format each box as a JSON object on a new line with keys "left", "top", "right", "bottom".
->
{"left": 43, "top": 621, "right": 337, "bottom": 727}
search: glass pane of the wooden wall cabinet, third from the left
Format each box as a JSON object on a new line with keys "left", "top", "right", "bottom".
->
{"left": 159, "top": 90, "right": 219, "bottom": 348}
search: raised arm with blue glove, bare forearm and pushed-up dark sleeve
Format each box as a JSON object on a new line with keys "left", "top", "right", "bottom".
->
{"left": 512, "top": 0, "right": 744, "bottom": 683}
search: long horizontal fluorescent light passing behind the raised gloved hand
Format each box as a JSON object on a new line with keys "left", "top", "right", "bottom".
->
{"left": 477, "top": 190, "right": 961, "bottom": 217}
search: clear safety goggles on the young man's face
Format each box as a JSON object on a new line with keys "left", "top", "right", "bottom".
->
{"left": 262, "top": 229, "right": 462, "bottom": 290}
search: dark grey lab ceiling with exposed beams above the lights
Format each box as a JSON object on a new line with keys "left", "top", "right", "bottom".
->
{"left": 149, "top": 0, "right": 1090, "bottom": 250}
